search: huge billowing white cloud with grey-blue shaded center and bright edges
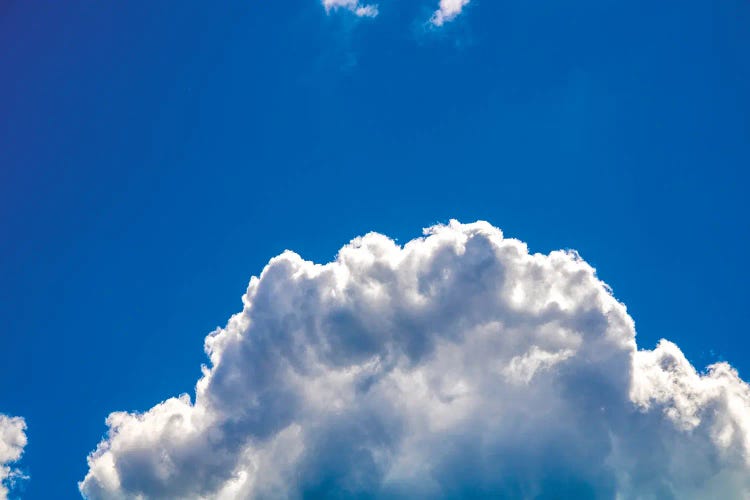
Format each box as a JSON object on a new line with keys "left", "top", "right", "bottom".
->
{"left": 79, "top": 221, "right": 750, "bottom": 499}
